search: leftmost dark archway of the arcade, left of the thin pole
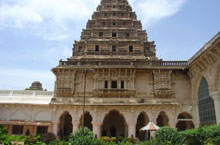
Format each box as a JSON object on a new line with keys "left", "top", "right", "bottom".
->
{"left": 59, "top": 112, "right": 73, "bottom": 137}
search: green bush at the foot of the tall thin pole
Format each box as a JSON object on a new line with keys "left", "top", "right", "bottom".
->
{"left": 69, "top": 127, "right": 95, "bottom": 145}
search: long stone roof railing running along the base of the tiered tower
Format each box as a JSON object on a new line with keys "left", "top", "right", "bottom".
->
{"left": 59, "top": 60, "right": 188, "bottom": 67}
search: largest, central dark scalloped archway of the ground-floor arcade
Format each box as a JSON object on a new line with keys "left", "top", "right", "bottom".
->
{"left": 102, "top": 110, "right": 127, "bottom": 137}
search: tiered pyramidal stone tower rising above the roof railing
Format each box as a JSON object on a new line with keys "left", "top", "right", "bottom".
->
{"left": 71, "top": 0, "right": 156, "bottom": 60}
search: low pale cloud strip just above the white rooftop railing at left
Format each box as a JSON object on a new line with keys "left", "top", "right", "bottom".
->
{"left": 0, "top": 68, "right": 55, "bottom": 90}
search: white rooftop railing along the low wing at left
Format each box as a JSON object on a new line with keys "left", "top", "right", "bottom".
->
{"left": 0, "top": 90, "right": 54, "bottom": 97}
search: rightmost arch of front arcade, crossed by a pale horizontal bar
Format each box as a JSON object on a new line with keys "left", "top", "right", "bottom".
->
{"left": 176, "top": 113, "right": 195, "bottom": 131}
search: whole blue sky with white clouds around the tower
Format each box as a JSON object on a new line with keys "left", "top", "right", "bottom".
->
{"left": 0, "top": 0, "right": 220, "bottom": 90}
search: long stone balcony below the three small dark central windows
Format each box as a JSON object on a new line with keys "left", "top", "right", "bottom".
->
{"left": 93, "top": 89, "right": 135, "bottom": 98}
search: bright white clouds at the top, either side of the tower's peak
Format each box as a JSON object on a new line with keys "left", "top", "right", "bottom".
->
{"left": 0, "top": 0, "right": 186, "bottom": 40}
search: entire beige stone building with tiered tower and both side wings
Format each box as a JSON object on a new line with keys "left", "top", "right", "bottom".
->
{"left": 0, "top": 0, "right": 220, "bottom": 138}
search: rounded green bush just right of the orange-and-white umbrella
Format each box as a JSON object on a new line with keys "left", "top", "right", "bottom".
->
{"left": 156, "top": 127, "right": 184, "bottom": 145}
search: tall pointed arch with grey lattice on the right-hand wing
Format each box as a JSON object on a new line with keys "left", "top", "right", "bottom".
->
{"left": 198, "top": 77, "right": 216, "bottom": 125}
